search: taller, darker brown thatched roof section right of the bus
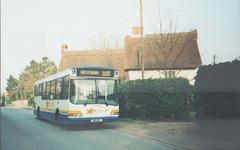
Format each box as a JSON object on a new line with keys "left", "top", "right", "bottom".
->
{"left": 124, "top": 30, "right": 202, "bottom": 70}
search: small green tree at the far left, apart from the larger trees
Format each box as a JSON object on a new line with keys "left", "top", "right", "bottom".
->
{"left": 6, "top": 75, "right": 18, "bottom": 100}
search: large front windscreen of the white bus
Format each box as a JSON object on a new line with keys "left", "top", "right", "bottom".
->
{"left": 70, "top": 79, "right": 118, "bottom": 106}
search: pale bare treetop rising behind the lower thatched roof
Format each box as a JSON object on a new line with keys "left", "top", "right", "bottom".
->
{"left": 90, "top": 33, "right": 124, "bottom": 50}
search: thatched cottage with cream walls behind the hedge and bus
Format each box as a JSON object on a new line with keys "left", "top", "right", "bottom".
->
{"left": 58, "top": 30, "right": 202, "bottom": 84}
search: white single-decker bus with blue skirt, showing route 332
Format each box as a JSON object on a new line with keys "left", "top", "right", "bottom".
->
{"left": 34, "top": 67, "right": 119, "bottom": 124}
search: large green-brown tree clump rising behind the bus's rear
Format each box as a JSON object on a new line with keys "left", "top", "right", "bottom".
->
{"left": 17, "top": 57, "right": 57, "bottom": 99}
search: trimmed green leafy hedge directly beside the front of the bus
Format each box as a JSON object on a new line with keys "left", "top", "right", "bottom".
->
{"left": 119, "top": 78, "right": 190, "bottom": 120}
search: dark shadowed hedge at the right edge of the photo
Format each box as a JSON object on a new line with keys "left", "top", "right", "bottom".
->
{"left": 194, "top": 61, "right": 240, "bottom": 119}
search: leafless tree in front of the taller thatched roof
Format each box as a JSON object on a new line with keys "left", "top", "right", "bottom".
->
{"left": 146, "top": 14, "right": 196, "bottom": 77}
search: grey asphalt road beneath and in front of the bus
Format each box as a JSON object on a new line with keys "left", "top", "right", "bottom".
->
{"left": 1, "top": 107, "right": 172, "bottom": 150}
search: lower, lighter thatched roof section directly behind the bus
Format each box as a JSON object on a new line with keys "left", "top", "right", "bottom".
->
{"left": 58, "top": 49, "right": 124, "bottom": 79}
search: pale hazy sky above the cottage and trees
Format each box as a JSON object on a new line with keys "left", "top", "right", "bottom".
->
{"left": 1, "top": 0, "right": 240, "bottom": 92}
